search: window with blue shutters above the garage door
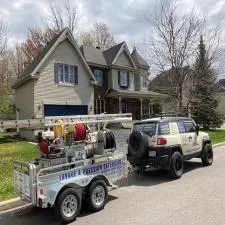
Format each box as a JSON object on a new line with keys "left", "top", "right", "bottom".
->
{"left": 54, "top": 63, "right": 78, "bottom": 84}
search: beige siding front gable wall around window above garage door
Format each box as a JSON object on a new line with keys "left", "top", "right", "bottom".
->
{"left": 34, "top": 40, "right": 94, "bottom": 118}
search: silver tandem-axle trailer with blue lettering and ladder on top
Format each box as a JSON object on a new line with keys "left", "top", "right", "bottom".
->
{"left": 8, "top": 114, "right": 132, "bottom": 223}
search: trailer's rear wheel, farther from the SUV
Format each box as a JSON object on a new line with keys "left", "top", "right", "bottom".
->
{"left": 54, "top": 188, "right": 81, "bottom": 224}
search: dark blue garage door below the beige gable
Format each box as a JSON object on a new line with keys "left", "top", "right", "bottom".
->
{"left": 44, "top": 105, "right": 88, "bottom": 116}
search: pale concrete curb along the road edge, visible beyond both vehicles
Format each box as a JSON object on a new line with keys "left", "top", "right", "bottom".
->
{"left": 0, "top": 142, "right": 225, "bottom": 213}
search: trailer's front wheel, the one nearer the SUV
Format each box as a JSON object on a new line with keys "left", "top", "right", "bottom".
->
{"left": 85, "top": 180, "right": 108, "bottom": 212}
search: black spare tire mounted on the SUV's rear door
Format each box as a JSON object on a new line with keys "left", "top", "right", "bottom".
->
{"left": 128, "top": 131, "right": 148, "bottom": 159}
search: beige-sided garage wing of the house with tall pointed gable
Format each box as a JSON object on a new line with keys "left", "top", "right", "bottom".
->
{"left": 13, "top": 28, "right": 95, "bottom": 119}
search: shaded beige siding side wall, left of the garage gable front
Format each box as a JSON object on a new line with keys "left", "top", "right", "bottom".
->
{"left": 15, "top": 80, "right": 34, "bottom": 119}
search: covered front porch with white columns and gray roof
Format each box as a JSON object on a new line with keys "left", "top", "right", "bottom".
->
{"left": 107, "top": 91, "right": 167, "bottom": 120}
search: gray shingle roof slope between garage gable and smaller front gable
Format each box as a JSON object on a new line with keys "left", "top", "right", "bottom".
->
{"left": 80, "top": 46, "right": 107, "bottom": 66}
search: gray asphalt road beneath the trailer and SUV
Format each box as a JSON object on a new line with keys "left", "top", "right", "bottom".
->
{"left": 0, "top": 130, "right": 225, "bottom": 225}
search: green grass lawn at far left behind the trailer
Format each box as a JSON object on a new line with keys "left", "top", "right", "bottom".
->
{"left": 0, "top": 133, "right": 38, "bottom": 201}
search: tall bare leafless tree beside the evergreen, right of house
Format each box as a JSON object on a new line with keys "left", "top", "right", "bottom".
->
{"left": 148, "top": 0, "right": 204, "bottom": 111}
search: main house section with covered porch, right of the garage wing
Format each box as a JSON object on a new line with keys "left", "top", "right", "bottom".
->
{"left": 81, "top": 42, "right": 167, "bottom": 120}
